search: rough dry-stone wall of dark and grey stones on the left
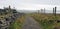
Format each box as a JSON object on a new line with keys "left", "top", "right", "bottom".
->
{"left": 0, "top": 9, "right": 21, "bottom": 29}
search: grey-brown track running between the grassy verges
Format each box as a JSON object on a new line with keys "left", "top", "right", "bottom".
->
{"left": 22, "top": 17, "right": 41, "bottom": 29}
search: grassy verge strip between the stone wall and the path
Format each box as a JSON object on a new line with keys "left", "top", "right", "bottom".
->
{"left": 10, "top": 16, "right": 25, "bottom": 29}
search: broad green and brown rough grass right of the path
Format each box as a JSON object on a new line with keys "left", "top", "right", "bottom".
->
{"left": 29, "top": 14, "right": 60, "bottom": 29}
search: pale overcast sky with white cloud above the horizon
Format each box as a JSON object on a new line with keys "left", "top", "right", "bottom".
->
{"left": 0, "top": 0, "right": 60, "bottom": 10}
